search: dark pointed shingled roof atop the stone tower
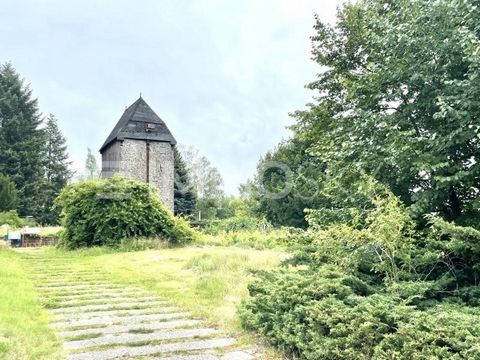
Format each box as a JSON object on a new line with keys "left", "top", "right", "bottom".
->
{"left": 100, "top": 97, "right": 177, "bottom": 152}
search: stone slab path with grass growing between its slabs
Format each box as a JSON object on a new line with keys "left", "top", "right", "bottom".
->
{"left": 23, "top": 251, "right": 259, "bottom": 360}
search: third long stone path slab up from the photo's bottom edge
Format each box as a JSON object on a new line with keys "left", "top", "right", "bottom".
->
{"left": 52, "top": 313, "right": 188, "bottom": 328}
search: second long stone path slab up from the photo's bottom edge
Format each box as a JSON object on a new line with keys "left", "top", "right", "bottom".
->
{"left": 64, "top": 328, "right": 217, "bottom": 350}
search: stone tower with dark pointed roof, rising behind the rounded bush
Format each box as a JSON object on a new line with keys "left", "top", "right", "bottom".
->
{"left": 100, "top": 96, "right": 176, "bottom": 212}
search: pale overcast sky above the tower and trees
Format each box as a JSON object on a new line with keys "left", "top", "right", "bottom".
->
{"left": 0, "top": 0, "right": 341, "bottom": 193}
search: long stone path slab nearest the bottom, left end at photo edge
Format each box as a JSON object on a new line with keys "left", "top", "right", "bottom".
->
{"left": 67, "top": 338, "right": 235, "bottom": 360}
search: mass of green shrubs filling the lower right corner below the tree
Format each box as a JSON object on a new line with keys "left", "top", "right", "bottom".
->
{"left": 241, "top": 183, "right": 480, "bottom": 360}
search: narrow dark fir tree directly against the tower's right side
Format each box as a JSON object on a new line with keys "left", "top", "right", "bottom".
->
{"left": 173, "top": 148, "right": 197, "bottom": 216}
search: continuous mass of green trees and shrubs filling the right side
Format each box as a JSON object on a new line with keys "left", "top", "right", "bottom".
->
{"left": 242, "top": 0, "right": 480, "bottom": 360}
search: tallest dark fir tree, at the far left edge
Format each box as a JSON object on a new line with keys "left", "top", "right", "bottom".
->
{"left": 0, "top": 63, "right": 45, "bottom": 217}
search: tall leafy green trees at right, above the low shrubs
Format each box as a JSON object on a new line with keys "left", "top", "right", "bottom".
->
{"left": 249, "top": 0, "right": 480, "bottom": 229}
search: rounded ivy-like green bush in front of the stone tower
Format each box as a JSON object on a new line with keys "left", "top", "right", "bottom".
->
{"left": 52, "top": 177, "right": 196, "bottom": 248}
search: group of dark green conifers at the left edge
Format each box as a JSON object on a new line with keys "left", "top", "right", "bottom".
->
{"left": 0, "top": 63, "right": 72, "bottom": 224}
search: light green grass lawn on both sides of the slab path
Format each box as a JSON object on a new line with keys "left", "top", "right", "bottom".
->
{"left": 0, "top": 246, "right": 284, "bottom": 359}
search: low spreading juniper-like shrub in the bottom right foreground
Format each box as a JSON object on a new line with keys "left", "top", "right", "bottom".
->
{"left": 241, "top": 265, "right": 480, "bottom": 360}
